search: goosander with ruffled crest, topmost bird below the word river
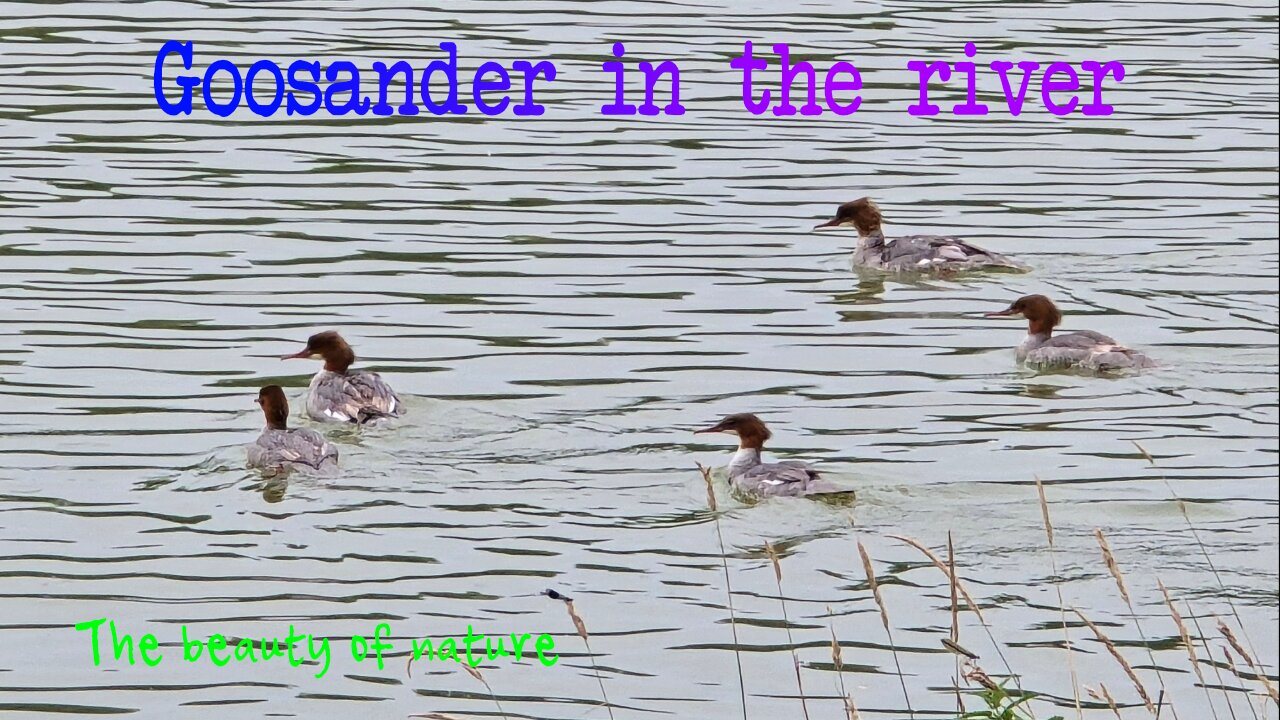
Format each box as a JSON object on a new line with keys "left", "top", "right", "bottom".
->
{"left": 814, "top": 197, "right": 1028, "bottom": 273}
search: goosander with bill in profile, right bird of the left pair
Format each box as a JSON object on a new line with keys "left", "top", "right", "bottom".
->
{"left": 283, "top": 331, "right": 404, "bottom": 424}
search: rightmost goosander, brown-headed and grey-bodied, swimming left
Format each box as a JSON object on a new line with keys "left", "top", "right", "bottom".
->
{"left": 987, "top": 295, "right": 1156, "bottom": 372}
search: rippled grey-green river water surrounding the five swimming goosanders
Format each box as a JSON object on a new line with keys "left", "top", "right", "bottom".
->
{"left": 0, "top": 0, "right": 1277, "bottom": 719}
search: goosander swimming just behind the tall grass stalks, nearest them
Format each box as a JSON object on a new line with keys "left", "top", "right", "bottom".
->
{"left": 694, "top": 413, "right": 847, "bottom": 497}
